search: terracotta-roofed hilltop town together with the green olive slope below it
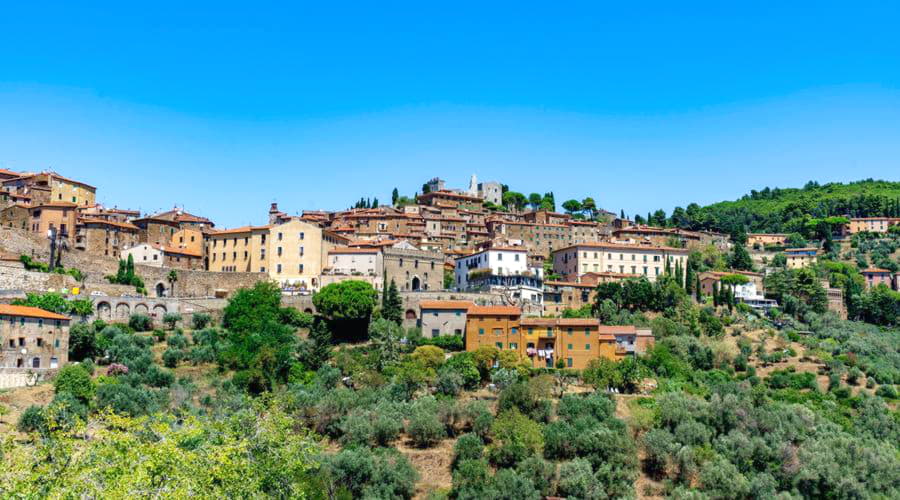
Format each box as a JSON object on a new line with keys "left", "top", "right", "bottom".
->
{"left": 0, "top": 170, "right": 900, "bottom": 498}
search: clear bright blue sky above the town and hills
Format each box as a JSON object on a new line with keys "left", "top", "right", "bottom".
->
{"left": 0, "top": 1, "right": 900, "bottom": 226}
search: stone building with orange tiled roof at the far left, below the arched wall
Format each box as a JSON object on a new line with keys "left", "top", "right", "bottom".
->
{"left": 0, "top": 304, "right": 69, "bottom": 373}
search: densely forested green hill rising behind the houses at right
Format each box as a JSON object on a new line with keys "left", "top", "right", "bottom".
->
{"left": 660, "top": 179, "right": 900, "bottom": 233}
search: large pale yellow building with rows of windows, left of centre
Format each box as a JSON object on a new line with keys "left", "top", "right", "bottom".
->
{"left": 206, "top": 219, "right": 349, "bottom": 290}
